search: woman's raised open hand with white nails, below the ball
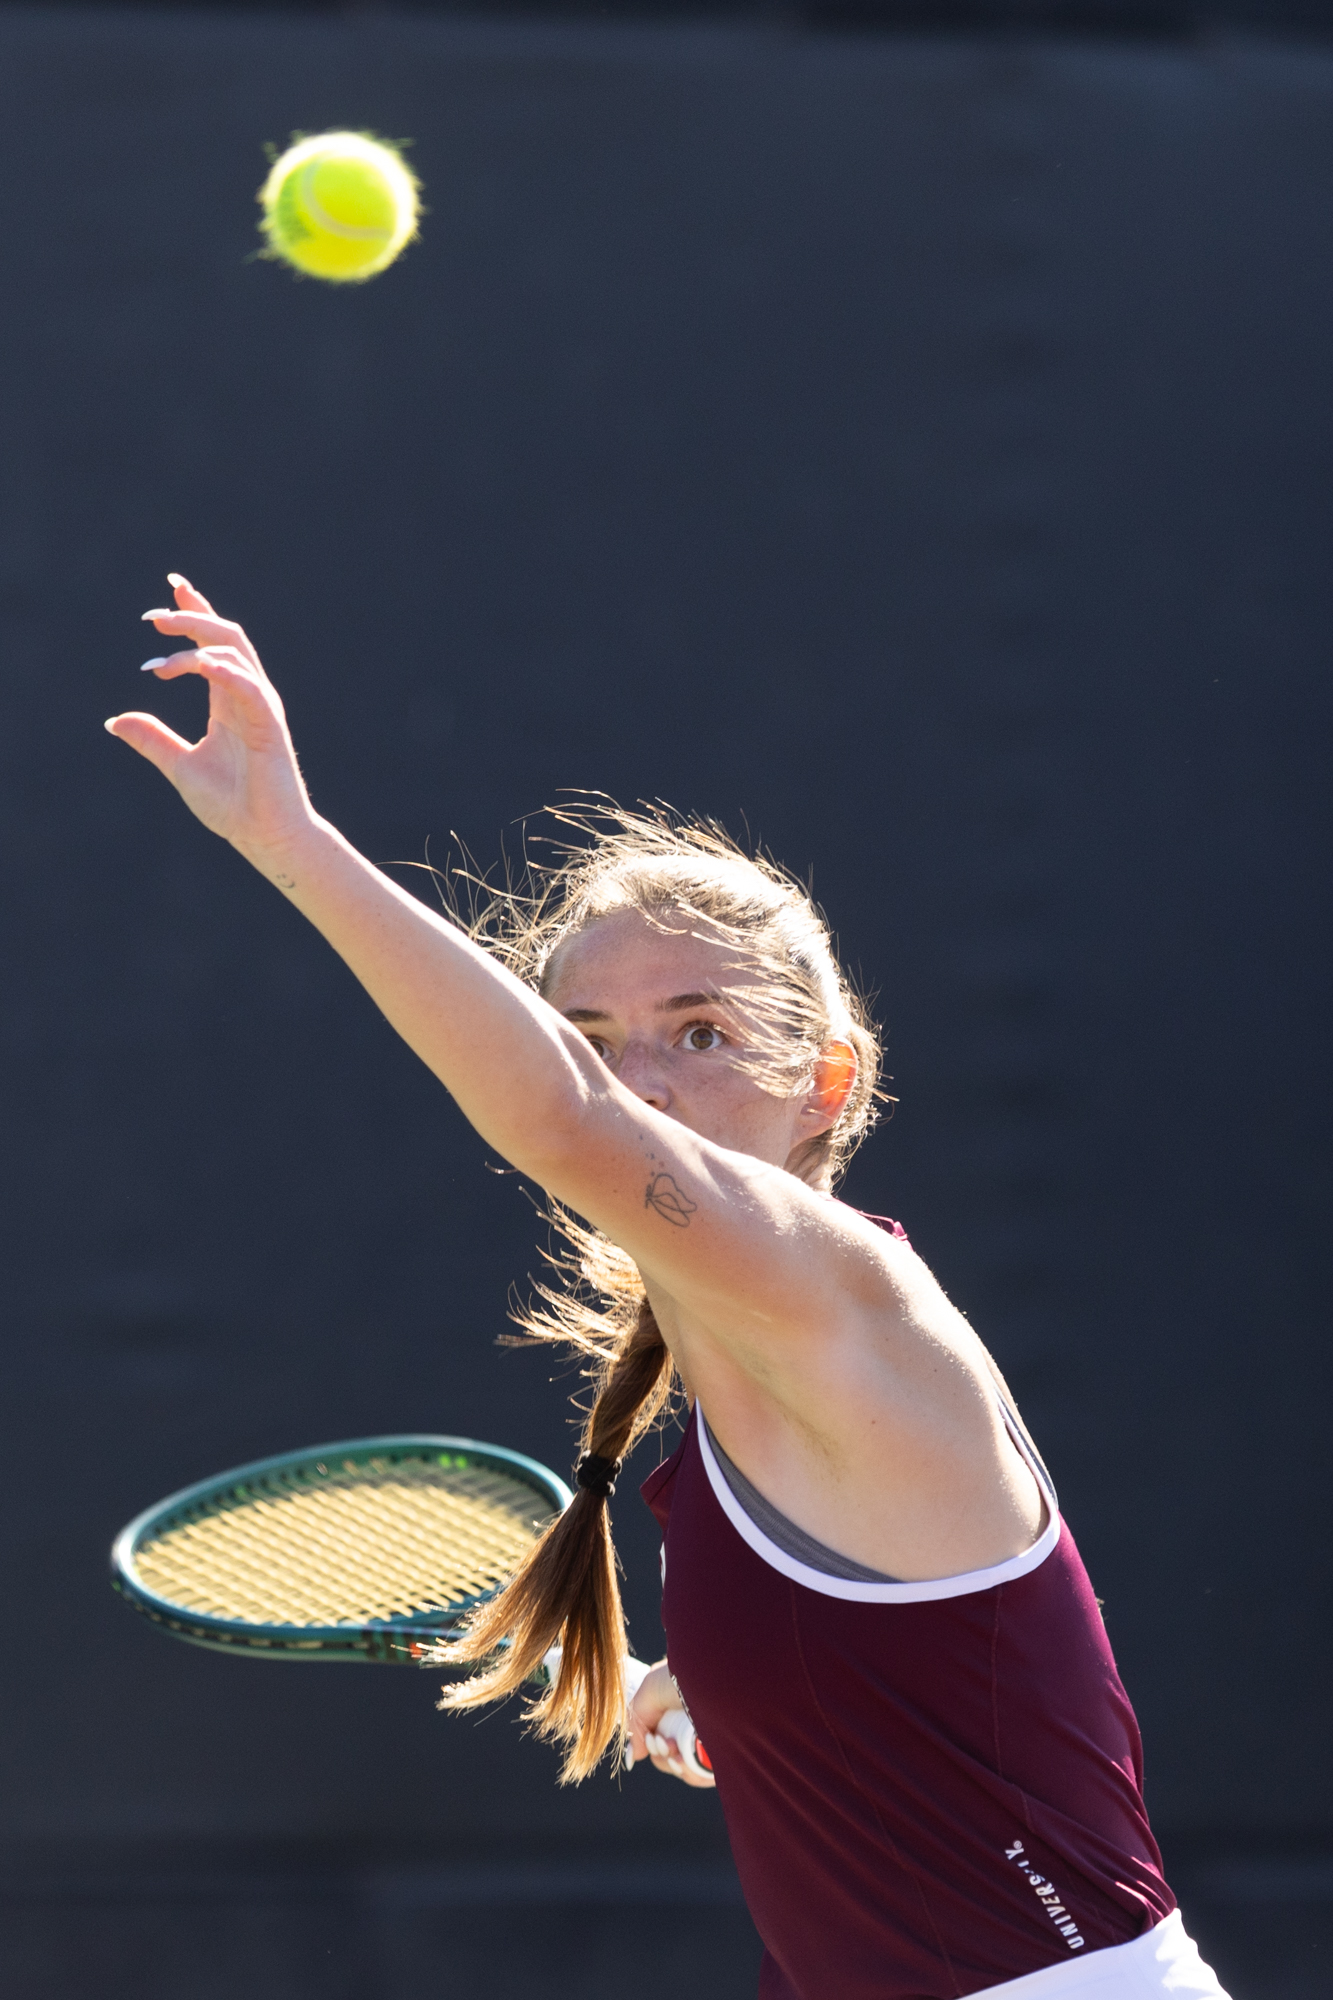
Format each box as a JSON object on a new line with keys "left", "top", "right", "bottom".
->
{"left": 106, "top": 574, "right": 312, "bottom": 854}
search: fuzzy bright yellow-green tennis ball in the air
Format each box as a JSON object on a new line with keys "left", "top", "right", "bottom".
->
{"left": 258, "top": 132, "right": 416, "bottom": 284}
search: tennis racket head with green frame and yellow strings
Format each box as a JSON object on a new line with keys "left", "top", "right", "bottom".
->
{"left": 112, "top": 1434, "right": 572, "bottom": 1672}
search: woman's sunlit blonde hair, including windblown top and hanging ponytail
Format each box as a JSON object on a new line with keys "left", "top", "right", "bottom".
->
{"left": 436, "top": 804, "right": 885, "bottom": 1782}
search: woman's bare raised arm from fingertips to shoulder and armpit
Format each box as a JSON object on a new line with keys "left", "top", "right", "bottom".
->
{"left": 108, "top": 578, "right": 1039, "bottom": 1576}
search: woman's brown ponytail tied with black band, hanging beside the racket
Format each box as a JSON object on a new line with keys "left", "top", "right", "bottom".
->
{"left": 432, "top": 1298, "right": 673, "bottom": 1784}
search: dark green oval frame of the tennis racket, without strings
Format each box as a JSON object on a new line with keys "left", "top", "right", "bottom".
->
{"left": 112, "top": 1432, "right": 574, "bottom": 1672}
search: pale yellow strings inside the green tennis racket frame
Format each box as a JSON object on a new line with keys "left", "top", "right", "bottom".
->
{"left": 136, "top": 1464, "right": 550, "bottom": 1626}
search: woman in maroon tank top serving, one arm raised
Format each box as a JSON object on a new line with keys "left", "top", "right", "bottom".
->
{"left": 106, "top": 576, "right": 1221, "bottom": 2000}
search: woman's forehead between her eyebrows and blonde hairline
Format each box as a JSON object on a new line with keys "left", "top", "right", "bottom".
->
{"left": 544, "top": 910, "right": 737, "bottom": 1012}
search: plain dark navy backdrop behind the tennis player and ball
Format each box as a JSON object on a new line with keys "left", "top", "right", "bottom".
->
{"left": 0, "top": 0, "right": 1333, "bottom": 2000}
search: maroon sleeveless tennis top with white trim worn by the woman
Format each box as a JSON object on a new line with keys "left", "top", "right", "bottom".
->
{"left": 642, "top": 1224, "right": 1175, "bottom": 2000}
